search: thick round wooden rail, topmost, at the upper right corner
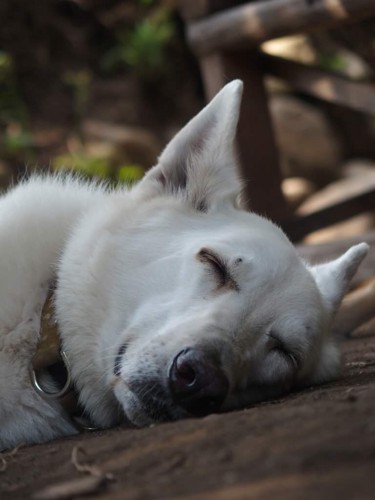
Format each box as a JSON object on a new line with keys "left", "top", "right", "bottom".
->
{"left": 187, "top": 0, "right": 375, "bottom": 53}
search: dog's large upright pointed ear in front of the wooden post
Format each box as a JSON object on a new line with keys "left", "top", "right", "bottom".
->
{"left": 138, "top": 80, "right": 243, "bottom": 211}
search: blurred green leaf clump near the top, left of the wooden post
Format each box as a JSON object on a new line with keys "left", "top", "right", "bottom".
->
{"left": 102, "top": 7, "right": 174, "bottom": 81}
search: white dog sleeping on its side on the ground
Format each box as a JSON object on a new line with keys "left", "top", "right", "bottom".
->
{"left": 0, "top": 81, "right": 368, "bottom": 449}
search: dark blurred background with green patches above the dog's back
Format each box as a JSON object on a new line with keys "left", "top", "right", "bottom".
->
{"left": 0, "top": 0, "right": 204, "bottom": 187}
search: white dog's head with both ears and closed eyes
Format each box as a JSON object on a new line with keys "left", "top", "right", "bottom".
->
{"left": 64, "top": 81, "right": 367, "bottom": 425}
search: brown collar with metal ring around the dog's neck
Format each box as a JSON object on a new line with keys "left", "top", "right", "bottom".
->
{"left": 29, "top": 286, "right": 93, "bottom": 430}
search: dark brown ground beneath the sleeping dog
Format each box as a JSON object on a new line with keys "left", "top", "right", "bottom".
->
{"left": 0, "top": 337, "right": 375, "bottom": 500}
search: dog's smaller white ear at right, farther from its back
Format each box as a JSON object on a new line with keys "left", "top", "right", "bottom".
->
{"left": 310, "top": 243, "right": 369, "bottom": 313}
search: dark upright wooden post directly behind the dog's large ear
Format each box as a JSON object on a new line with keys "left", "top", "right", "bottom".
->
{"left": 200, "top": 51, "right": 289, "bottom": 223}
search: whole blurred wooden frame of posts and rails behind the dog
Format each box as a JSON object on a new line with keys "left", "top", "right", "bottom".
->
{"left": 180, "top": 0, "right": 375, "bottom": 240}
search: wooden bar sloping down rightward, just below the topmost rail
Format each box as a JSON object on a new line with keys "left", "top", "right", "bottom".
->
{"left": 263, "top": 53, "right": 375, "bottom": 115}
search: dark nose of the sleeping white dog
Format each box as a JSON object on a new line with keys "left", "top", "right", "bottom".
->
{"left": 169, "top": 348, "right": 229, "bottom": 417}
